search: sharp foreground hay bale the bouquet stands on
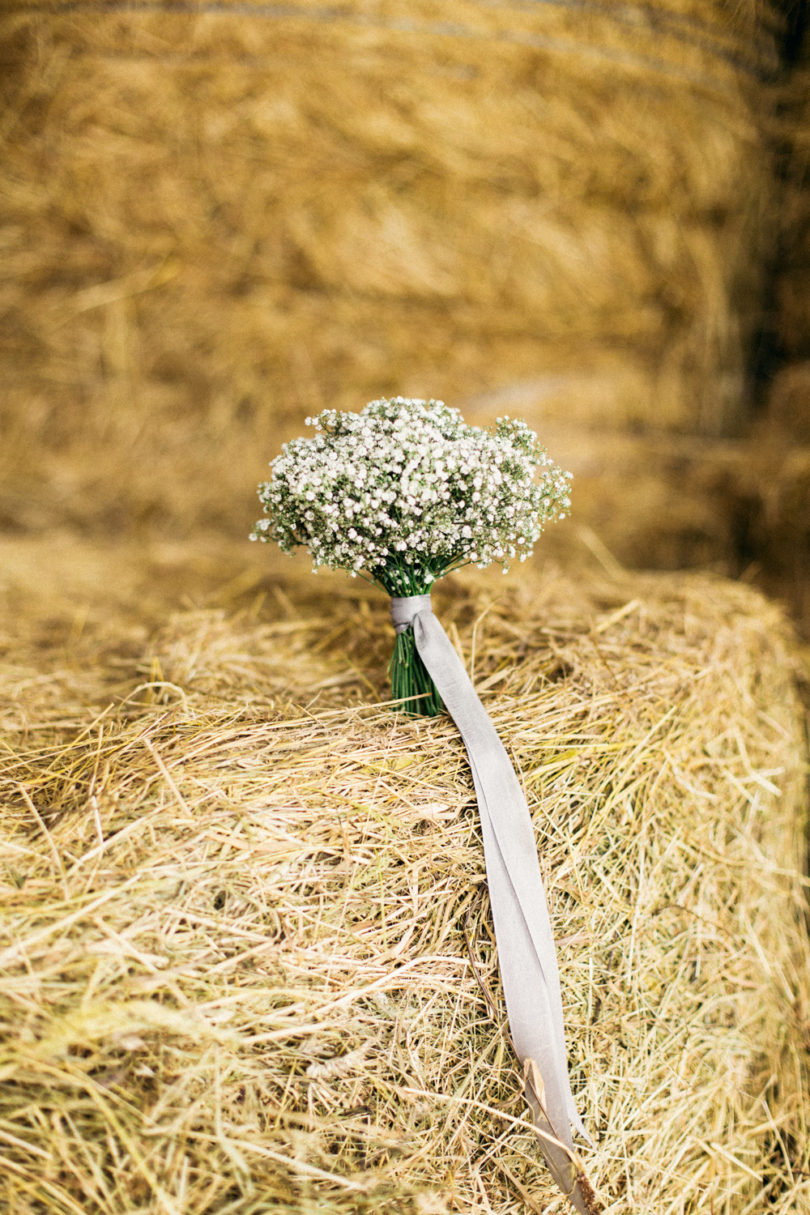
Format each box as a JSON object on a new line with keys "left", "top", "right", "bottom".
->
{"left": 0, "top": 552, "right": 810, "bottom": 1215}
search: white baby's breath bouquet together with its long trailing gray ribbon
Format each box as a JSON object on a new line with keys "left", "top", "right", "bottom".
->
{"left": 251, "top": 397, "right": 597, "bottom": 1215}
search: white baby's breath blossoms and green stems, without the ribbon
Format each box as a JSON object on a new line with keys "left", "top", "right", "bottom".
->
{"left": 251, "top": 396, "right": 571, "bottom": 716}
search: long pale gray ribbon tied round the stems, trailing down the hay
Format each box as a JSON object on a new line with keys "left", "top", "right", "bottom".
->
{"left": 391, "top": 595, "right": 596, "bottom": 1215}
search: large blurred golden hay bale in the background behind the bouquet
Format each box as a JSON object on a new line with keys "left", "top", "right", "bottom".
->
{"left": 0, "top": 0, "right": 775, "bottom": 533}
